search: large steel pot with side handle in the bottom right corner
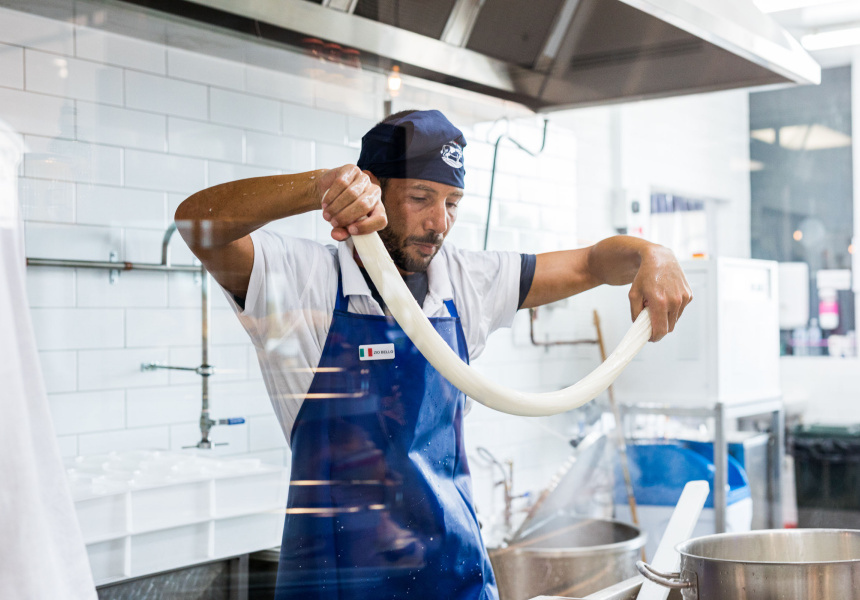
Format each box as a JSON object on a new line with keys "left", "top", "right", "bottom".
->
{"left": 636, "top": 529, "right": 860, "bottom": 600}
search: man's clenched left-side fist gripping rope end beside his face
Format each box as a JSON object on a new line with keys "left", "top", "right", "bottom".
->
{"left": 317, "top": 165, "right": 388, "bottom": 242}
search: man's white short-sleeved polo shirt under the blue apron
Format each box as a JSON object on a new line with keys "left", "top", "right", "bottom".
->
{"left": 224, "top": 229, "right": 521, "bottom": 442}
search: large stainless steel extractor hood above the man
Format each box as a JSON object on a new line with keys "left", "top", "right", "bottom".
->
{"left": 119, "top": 0, "right": 821, "bottom": 111}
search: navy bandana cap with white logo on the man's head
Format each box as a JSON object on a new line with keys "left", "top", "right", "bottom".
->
{"left": 358, "top": 110, "right": 466, "bottom": 188}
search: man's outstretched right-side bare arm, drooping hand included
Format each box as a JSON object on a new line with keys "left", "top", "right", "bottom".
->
{"left": 523, "top": 235, "right": 693, "bottom": 342}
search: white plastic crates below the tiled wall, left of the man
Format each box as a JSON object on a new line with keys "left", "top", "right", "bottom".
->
{"left": 66, "top": 450, "right": 288, "bottom": 585}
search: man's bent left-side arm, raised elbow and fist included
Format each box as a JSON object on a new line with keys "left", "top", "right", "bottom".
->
{"left": 175, "top": 165, "right": 387, "bottom": 299}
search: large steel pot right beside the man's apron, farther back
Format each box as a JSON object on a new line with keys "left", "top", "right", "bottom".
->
{"left": 490, "top": 516, "right": 645, "bottom": 600}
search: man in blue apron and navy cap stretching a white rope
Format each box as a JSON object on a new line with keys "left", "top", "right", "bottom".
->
{"left": 176, "top": 111, "right": 691, "bottom": 600}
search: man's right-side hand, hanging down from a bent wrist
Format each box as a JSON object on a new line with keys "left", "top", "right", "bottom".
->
{"left": 628, "top": 246, "right": 693, "bottom": 342}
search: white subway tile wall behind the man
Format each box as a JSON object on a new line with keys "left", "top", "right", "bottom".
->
{"left": 0, "top": 2, "right": 746, "bottom": 517}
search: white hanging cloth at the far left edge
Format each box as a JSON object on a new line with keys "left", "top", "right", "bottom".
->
{"left": 0, "top": 121, "right": 97, "bottom": 600}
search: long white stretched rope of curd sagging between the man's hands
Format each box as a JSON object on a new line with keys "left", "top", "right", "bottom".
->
{"left": 352, "top": 233, "right": 651, "bottom": 417}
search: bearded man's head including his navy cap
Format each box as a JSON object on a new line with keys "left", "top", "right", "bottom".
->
{"left": 358, "top": 110, "right": 466, "bottom": 272}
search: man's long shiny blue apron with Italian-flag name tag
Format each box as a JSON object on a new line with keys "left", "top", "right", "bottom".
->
{"left": 275, "top": 276, "right": 498, "bottom": 600}
